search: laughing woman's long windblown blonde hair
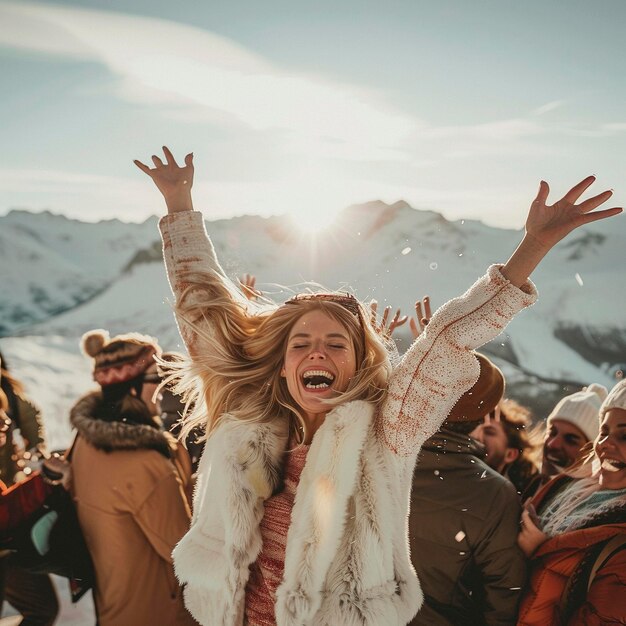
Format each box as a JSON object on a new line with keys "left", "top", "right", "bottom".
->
{"left": 161, "top": 272, "right": 391, "bottom": 441}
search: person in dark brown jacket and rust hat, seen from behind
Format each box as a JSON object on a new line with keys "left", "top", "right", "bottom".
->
{"left": 409, "top": 354, "right": 526, "bottom": 626}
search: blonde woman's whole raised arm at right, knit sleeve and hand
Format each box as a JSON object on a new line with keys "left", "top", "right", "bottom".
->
{"left": 378, "top": 176, "right": 622, "bottom": 455}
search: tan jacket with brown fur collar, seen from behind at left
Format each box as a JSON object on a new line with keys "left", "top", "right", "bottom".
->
{"left": 71, "top": 392, "right": 196, "bottom": 626}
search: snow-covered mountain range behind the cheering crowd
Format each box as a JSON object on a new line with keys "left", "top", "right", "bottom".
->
{"left": 0, "top": 202, "right": 626, "bottom": 441}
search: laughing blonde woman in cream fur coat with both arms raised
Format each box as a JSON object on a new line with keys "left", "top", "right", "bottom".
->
{"left": 135, "top": 148, "right": 621, "bottom": 626}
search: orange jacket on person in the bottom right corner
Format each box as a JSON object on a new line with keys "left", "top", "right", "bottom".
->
{"left": 518, "top": 476, "right": 626, "bottom": 626}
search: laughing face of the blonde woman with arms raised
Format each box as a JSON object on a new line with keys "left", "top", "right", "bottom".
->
{"left": 281, "top": 310, "right": 356, "bottom": 419}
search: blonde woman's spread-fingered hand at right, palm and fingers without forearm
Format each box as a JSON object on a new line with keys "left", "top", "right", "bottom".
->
{"left": 526, "top": 176, "right": 622, "bottom": 249}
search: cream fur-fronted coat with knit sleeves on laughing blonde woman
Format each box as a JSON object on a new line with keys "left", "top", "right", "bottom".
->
{"left": 161, "top": 212, "right": 535, "bottom": 626}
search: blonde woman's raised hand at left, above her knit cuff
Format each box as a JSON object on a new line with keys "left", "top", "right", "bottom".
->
{"left": 134, "top": 146, "right": 194, "bottom": 213}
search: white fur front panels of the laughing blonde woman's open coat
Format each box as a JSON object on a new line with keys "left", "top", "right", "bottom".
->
{"left": 173, "top": 400, "right": 374, "bottom": 626}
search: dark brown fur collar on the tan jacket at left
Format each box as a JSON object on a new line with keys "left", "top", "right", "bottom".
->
{"left": 70, "top": 391, "right": 176, "bottom": 459}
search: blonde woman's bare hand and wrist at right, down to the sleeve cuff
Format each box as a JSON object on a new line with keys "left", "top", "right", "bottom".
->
{"left": 502, "top": 176, "right": 622, "bottom": 287}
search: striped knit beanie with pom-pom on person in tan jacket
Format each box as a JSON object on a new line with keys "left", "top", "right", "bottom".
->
{"left": 81, "top": 329, "right": 161, "bottom": 387}
